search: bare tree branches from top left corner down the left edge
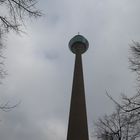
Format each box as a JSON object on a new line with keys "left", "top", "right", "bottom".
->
{"left": 0, "top": 0, "right": 42, "bottom": 79}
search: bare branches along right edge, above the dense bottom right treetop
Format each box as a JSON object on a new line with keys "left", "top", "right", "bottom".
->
{"left": 118, "top": 41, "right": 140, "bottom": 114}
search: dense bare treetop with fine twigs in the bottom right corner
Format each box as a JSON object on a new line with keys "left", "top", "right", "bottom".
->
{"left": 95, "top": 106, "right": 140, "bottom": 140}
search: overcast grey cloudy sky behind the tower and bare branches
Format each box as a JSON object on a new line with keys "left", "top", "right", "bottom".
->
{"left": 0, "top": 0, "right": 140, "bottom": 140}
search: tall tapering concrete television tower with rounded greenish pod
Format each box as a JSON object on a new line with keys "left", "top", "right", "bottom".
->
{"left": 67, "top": 34, "right": 89, "bottom": 140}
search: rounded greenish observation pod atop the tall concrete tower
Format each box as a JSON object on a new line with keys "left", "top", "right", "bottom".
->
{"left": 69, "top": 35, "right": 89, "bottom": 54}
